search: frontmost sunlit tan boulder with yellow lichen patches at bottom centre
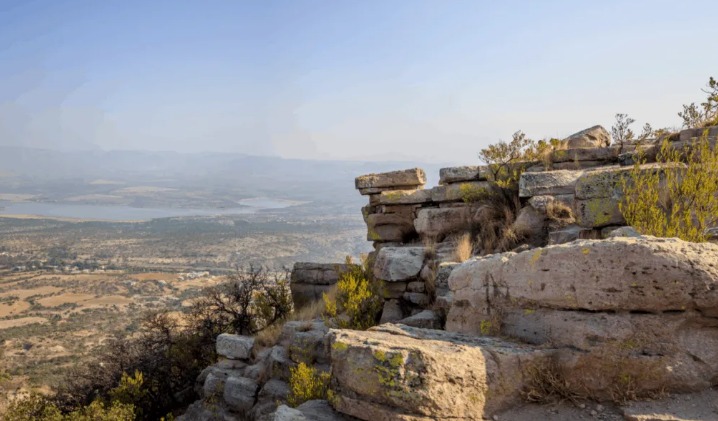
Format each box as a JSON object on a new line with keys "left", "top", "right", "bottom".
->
{"left": 330, "top": 325, "right": 551, "bottom": 421}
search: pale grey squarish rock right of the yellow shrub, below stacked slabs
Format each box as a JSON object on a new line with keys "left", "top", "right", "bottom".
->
{"left": 374, "top": 247, "right": 424, "bottom": 282}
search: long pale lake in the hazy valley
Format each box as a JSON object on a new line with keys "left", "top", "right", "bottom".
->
{"left": 0, "top": 197, "right": 302, "bottom": 221}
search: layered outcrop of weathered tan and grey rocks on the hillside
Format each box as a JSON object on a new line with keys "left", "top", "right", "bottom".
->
{"left": 184, "top": 127, "right": 718, "bottom": 421}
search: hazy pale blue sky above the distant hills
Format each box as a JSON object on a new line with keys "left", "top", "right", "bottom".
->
{"left": 0, "top": 0, "right": 718, "bottom": 163}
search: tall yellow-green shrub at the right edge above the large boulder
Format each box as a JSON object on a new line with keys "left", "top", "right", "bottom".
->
{"left": 619, "top": 133, "right": 718, "bottom": 242}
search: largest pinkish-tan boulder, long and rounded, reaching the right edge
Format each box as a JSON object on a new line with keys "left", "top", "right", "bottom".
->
{"left": 446, "top": 237, "right": 718, "bottom": 334}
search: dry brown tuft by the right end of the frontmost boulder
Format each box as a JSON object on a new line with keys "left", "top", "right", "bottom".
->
{"left": 521, "top": 360, "right": 587, "bottom": 403}
